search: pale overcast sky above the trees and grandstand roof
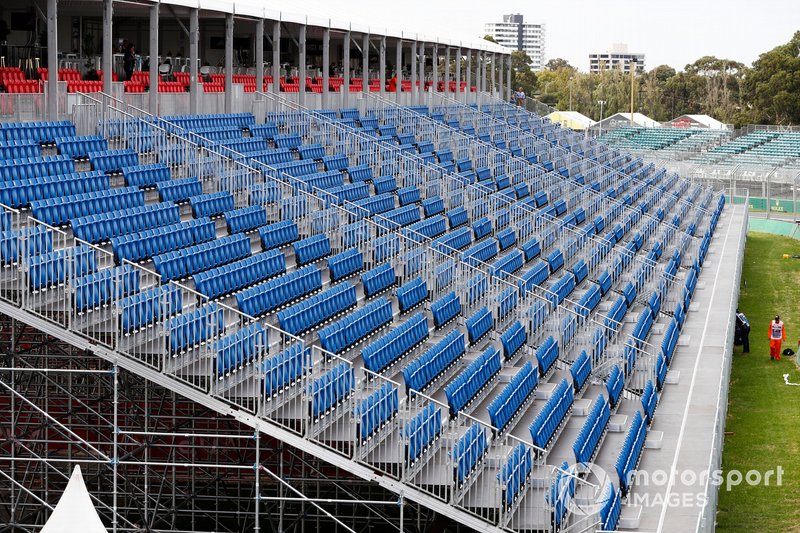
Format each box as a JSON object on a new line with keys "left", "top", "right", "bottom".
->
{"left": 269, "top": 0, "right": 800, "bottom": 71}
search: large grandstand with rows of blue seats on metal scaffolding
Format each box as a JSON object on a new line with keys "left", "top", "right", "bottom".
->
{"left": 0, "top": 0, "right": 746, "bottom": 531}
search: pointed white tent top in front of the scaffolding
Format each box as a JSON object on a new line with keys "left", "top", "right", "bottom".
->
{"left": 41, "top": 465, "right": 108, "bottom": 533}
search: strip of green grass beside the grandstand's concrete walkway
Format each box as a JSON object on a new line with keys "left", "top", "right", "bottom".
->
{"left": 717, "top": 233, "right": 800, "bottom": 532}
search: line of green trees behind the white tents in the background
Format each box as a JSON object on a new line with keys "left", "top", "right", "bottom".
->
{"left": 500, "top": 31, "right": 800, "bottom": 127}
